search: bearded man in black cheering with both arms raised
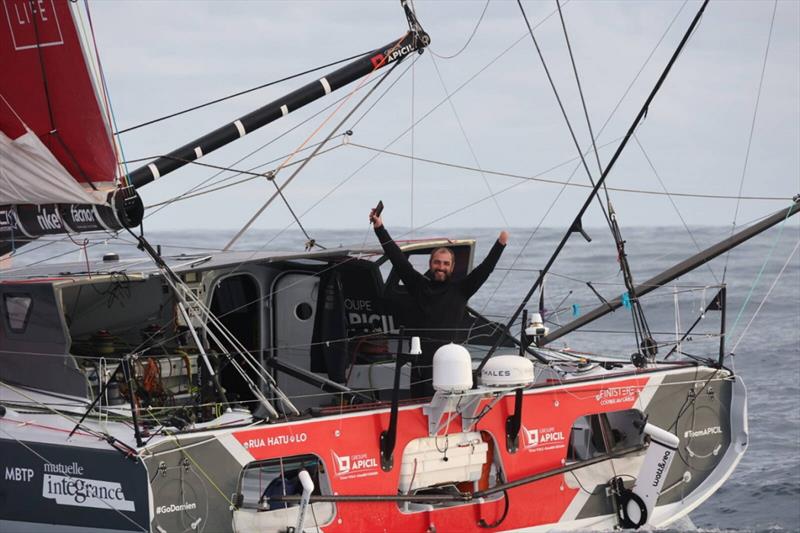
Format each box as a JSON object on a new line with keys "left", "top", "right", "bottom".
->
{"left": 369, "top": 209, "right": 508, "bottom": 398}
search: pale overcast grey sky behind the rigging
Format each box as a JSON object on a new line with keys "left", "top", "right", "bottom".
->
{"left": 90, "top": 0, "right": 800, "bottom": 232}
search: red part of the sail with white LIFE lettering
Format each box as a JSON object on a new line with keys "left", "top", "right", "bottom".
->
{"left": 0, "top": 0, "right": 117, "bottom": 187}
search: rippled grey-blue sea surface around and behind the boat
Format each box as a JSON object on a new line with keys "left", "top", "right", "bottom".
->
{"left": 6, "top": 220, "right": 800, "bottom": 531}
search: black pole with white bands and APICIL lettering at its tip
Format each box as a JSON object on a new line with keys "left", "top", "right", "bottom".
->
{"left": 128, "top": 0, "right": 430, "bottom": 188}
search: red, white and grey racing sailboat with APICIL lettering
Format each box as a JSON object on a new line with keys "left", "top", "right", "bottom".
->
{"left": 0, "top": 0, "right": 800, "bottom": 532}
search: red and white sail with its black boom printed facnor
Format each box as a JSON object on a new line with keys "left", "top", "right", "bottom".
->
{"left": 0, "top": 0, "right": 141, "bottom": 253}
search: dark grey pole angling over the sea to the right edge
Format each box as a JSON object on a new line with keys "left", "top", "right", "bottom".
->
{"left": 542, "top": 195, "right": 800, "bottom": 345}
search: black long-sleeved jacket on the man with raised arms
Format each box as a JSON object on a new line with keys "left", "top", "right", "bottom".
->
{"left": 375, "top": 226, "right": 505, "bottom": 342}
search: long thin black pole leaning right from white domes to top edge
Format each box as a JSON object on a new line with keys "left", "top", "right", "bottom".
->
{"left": 475, "top": 0, "right": 708, "bottom": 374}
